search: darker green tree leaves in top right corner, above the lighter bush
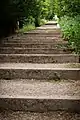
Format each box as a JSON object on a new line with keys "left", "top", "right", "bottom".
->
{"left": 54, "top": 0, "right": 80, "bottom": 17}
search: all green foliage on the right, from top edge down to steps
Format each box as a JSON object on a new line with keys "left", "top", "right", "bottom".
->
{"left": 54, "top": 0, "right": 80, "bottom": 54}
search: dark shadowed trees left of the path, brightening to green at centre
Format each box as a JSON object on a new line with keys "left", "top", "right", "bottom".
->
{"left": 0, "top": 0, "right": 54, "bottom": 35}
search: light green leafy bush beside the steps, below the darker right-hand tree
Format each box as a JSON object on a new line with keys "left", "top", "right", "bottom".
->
{"left": 60, "top": 15, "right": 80, "bottom": 54}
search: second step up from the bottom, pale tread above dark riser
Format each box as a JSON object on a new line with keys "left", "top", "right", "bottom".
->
{"left": 0, "top": 63, "right": 80, "bottom": 80}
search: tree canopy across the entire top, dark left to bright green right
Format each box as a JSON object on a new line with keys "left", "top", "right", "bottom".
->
{"left": 0, "top": 0, "right": 80, "bottom": 37}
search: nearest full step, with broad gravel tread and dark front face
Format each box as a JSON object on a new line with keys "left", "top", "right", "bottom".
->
{"left": 0, "top": 80, "right": 80, "bottom": 112}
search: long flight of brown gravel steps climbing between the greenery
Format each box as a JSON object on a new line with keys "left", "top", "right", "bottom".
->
{"left": 0, "top": 22, "right": 80, "bottom": 120}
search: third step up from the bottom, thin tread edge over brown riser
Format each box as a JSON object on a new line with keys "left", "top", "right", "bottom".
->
{"left": 0, "top": 54, "right": 79, "bottom": 64}
